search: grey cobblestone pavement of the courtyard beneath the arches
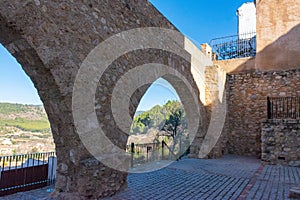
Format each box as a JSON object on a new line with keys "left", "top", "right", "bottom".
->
{"left": 2, "top": 155, "right": 300, "bottom": 200}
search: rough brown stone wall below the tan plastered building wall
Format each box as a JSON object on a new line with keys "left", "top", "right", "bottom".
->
{"left": 227, "top": 69, "right": 300, "bottom": 156}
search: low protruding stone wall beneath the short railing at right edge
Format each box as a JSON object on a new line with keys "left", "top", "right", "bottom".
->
{"left": 261, "top": 119, "right": 300, "bottom": 167}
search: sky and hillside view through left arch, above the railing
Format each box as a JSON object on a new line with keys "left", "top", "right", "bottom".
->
{"left": 0, "top": 45, "right": 55, "bottom": 156}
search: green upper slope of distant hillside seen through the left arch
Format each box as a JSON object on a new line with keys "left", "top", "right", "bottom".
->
{"left": 0, "top": 103, "right": 50, "bottom": 132}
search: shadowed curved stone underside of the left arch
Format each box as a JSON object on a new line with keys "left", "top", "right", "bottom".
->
{"left": 0, "top": 15, "right": 65, "bottom": 157}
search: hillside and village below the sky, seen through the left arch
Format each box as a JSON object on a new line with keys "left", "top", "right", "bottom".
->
{"left": 0, "top": 103, "right": 55, "bottom": 155}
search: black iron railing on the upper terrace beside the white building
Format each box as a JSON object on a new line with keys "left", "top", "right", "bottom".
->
{"left": 209, "top": 32, "right": 256, "bottom": 60}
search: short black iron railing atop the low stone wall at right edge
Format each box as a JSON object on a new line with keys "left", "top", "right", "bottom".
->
{"left": 267, "top": 97, "right": 300, "bottom": 119}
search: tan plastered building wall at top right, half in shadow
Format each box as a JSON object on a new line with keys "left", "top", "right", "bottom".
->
{"left": 256, "top": 0, "right": 300, "bottom": 71}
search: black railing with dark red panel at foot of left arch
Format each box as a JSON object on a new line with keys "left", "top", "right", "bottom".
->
{"left": 0, "top": 152, "right": 57, "bottom": 196}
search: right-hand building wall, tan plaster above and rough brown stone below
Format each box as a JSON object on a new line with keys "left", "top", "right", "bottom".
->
{"left": 218, "top": 0, "right": 300, "bottom": 159}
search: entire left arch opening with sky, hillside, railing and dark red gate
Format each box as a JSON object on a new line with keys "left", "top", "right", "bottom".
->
{"left": 0, "top": 43, "right": 57, "bottom": 196}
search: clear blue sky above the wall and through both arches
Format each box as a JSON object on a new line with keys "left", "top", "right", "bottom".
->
{"left": 0, "top": 0, "right": 251, "bottom": 110}
